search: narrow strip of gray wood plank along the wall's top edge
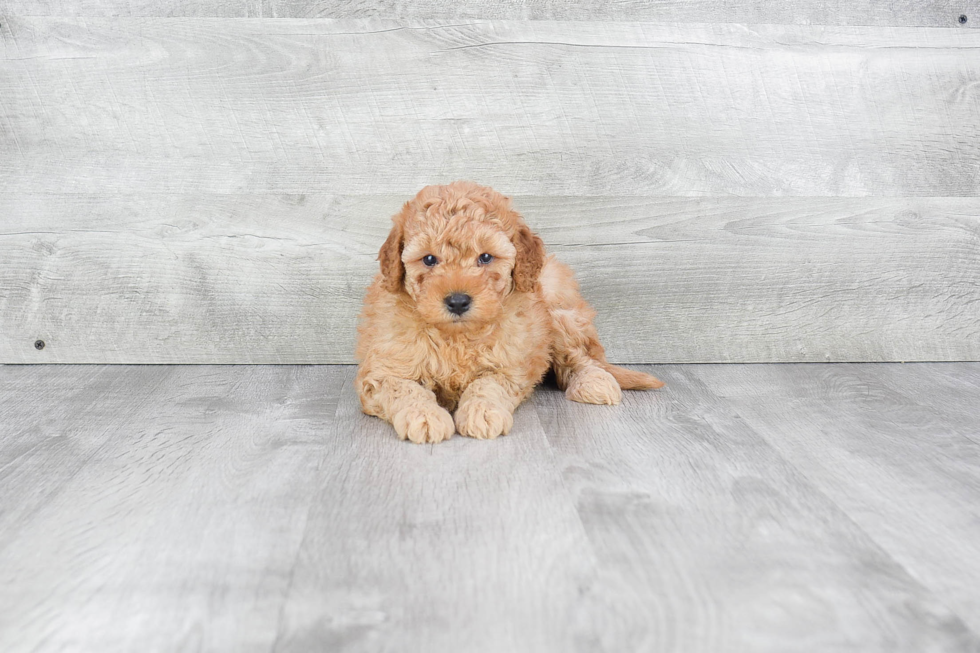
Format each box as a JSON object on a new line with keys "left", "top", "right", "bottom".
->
{"left": 0, "top": 0, "right": 980, "bottom": 27}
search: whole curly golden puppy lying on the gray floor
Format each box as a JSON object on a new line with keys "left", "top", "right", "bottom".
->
{"left": 356, "top": 182, "right": 663, "bottom": 442}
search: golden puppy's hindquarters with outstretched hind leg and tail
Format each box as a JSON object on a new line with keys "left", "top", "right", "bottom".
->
{"left": 541, "top": 258, "right": 663, "bottom": 404}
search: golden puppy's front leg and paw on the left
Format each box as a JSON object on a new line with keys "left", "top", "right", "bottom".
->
{"left": 357, "top": 374, "right": 456, "bottom": 444}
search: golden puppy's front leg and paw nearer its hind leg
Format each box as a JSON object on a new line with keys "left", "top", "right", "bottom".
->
{"left": 455, "top": 375, "right": 534, "bottom": 440}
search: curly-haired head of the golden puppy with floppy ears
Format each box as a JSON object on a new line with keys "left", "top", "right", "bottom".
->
{"left": 378, "top": 182, "right": 544, "bottom": 330}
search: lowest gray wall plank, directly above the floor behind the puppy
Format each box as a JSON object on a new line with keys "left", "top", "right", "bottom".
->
{"left": 0, "top": 194, "right": 980, "bottom": 363}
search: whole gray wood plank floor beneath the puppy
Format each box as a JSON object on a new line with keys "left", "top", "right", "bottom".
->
{"left": 0, "top": 363, "right": 980, "bottom": 653}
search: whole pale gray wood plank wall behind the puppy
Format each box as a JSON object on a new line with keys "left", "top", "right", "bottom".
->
{"left": 0, "top": 0, "right": 980, "bottom": 363}
